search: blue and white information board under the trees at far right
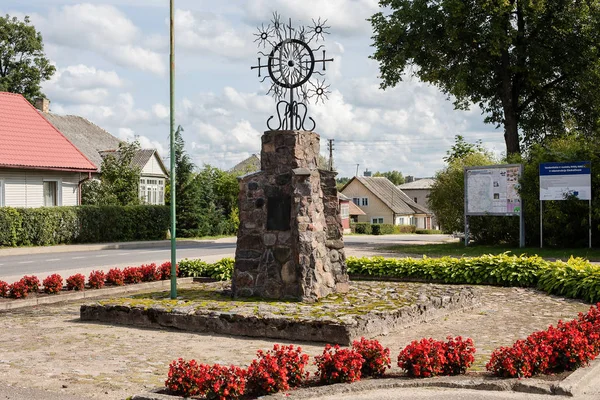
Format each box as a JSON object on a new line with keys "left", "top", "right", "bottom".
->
{"left": 540, "top": 161, "right": 592, "bottom": 200}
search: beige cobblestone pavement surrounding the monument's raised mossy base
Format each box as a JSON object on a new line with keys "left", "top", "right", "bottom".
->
{"left": 0, "top": 287, "right": 590, "bottom": 399}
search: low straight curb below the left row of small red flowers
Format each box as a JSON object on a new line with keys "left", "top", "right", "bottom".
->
{"left": 0, "top": 278, "right": 193, "bottom": 311}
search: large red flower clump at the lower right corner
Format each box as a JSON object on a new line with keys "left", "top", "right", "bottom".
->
{"left": 486, "top": 303, "right": 600, "bottom": 378}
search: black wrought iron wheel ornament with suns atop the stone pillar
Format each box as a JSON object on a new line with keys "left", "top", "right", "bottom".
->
{"left": 250, "top": 13, "right": 333, "bottom": 131}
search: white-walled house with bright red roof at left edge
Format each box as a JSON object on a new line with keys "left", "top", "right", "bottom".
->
{"left": 0, "top": 92, "right": 98, "bottom": 207}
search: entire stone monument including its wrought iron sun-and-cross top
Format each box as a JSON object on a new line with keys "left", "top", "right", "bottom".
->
{"left": 232, "top": 13, "right": 348, "bottom": 301}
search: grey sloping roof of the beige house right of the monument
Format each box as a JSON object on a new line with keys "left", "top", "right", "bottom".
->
{"left": 354, "top": 176, "right": 431, "bottom": 214}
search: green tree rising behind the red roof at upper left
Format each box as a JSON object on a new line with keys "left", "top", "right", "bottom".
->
{"left": 0, "top": 15, "right": 56, "bottom": 103}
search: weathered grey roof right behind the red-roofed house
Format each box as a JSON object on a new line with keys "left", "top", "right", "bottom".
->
{"left": 40, "top": 112, "right": 121, "bottom": 170}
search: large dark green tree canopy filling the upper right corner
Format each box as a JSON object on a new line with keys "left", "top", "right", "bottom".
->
{"left": 371, "top": 0, "right": 600, "bottom": 154}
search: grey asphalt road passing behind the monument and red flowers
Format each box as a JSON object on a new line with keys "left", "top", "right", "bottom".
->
{"left": 0, "top": 235, "right": 448, "bottom": 283}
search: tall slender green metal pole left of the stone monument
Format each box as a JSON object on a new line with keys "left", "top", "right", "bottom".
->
{"left": 169, "top": 0, "right": 177, "bottom": 300}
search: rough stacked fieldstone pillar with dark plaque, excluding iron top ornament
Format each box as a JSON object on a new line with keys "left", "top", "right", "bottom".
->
{"left": 232, "top": 131, "right": 348, "bottom": 301}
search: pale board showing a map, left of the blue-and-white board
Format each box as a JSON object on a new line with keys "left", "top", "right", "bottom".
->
{"left": 465, "top": 164, "right": 522, "bottom": 215}
